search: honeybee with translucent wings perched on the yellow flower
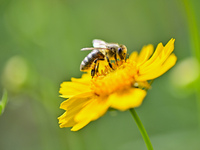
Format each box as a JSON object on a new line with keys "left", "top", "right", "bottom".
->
{"left": 80, "top": 39, "right": 127, "bottom": 78}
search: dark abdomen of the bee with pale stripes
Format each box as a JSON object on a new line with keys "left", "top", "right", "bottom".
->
{"left": 80, "top": 49, "right": 104, "bottom": 71}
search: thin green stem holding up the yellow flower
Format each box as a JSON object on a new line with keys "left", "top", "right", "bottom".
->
{"left": 130, "top": 108, "right": 153, "bottom": 150}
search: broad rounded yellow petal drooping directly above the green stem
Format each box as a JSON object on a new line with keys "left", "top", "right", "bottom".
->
{"left": 108, "top": 88, "right": 146, "bottom": 111}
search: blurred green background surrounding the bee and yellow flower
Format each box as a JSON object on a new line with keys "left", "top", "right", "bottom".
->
{"left": 0, "top": 0, "right": 200, "bottom": 150}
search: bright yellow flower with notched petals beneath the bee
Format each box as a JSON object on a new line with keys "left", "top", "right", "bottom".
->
{"left": 58, "top": 39, "right": 177, "bottom": 131}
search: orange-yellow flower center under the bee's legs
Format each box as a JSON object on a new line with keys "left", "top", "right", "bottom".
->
{"left": 91, "top": 61, "right": 137, "bottom": 96}
